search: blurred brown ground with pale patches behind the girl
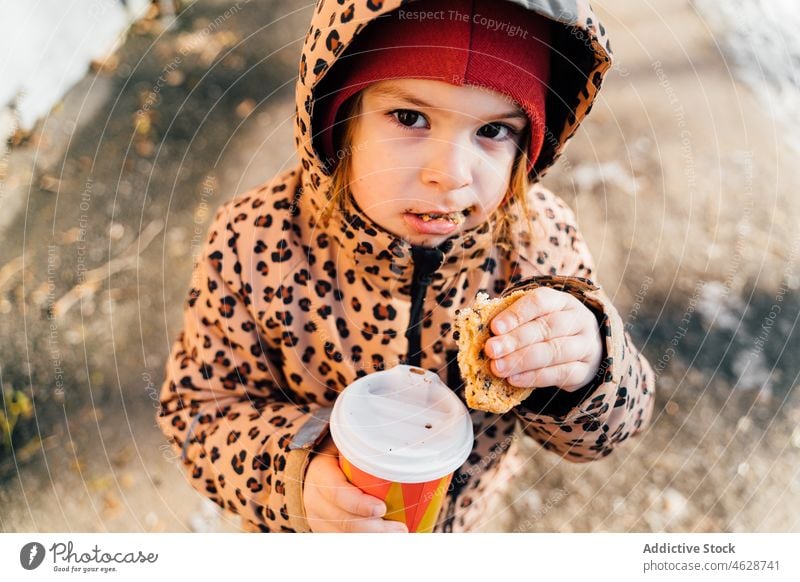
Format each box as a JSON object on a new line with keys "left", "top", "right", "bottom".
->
{"left": 0, "top": 0, "right": 800, "bottom": 532}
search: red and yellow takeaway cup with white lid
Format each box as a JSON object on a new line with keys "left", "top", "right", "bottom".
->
{"left": 330, "top": 365, "right": 473, "bottom": 533}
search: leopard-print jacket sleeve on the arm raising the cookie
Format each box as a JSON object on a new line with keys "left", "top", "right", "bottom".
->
{"left": 505, "top": 194, "right": 655, "bottom": 462}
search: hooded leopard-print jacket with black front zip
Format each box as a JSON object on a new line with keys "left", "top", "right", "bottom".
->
{"left": 157, "top": 0, "right": 654, "bottom": 532}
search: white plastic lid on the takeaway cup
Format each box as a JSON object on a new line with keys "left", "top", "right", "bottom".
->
{"left": 330, "top": 365, "right": 473, "bottom": 483}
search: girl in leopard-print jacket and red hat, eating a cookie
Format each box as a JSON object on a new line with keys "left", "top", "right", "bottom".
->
{"left": 158, "top": 0, "right": 654, "bottom": 532}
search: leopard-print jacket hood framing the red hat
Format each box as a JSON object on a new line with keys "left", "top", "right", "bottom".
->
{"left": 295, "top": 0, "right": 612, "bottom": 209}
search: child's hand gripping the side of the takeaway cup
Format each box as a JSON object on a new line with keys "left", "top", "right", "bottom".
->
{"left": 303, "top": 436, "right": 408, "bottom": 533}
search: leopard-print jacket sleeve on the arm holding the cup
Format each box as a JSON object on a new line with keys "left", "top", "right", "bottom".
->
{"left": 157, "top": 201, "right": 327, "bottom": 532}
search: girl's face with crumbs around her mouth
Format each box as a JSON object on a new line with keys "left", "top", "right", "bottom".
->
{"left": 350, "top": 79, "right": 528, "bottom": 246}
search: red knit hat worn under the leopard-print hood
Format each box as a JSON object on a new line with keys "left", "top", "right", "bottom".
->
{"left": 315, "top": 0, "right": 551, "bottom": 171}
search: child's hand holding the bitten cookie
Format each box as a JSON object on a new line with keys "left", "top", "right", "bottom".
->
{"left": 486, "top": 287, "right": 603, "bottom": 392}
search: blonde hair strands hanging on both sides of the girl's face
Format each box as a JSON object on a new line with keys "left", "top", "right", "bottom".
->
{"left": 321, "top": 92, "right": 538, "bottom": 250}
